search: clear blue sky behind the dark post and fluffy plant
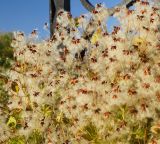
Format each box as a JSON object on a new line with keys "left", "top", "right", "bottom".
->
{"left": 0, "top": 0, "right": 121, "bottom": 37}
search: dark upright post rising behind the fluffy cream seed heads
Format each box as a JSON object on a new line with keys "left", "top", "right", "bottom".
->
{"left": 49, "top": 0, "right": 70, "bottom": 37}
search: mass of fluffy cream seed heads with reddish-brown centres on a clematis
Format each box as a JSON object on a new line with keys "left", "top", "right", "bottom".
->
{"left": 0, "top": 1, "right": 160, "bottom": 144}
